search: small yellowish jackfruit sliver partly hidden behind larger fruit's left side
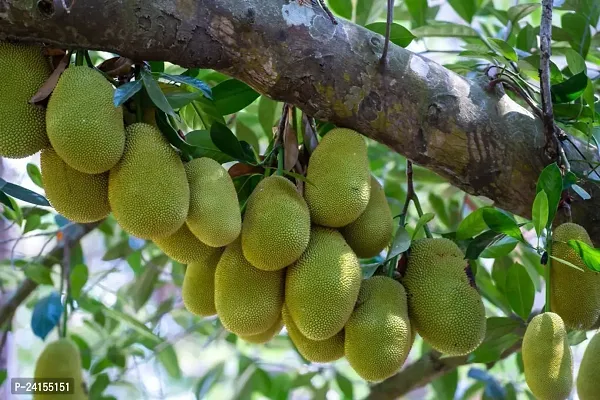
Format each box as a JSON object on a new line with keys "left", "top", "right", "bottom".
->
{"left": 181, "top": 249, "right": 223, "bottom": 317}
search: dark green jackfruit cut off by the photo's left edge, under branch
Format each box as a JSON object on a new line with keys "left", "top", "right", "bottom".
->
{"left": 0, "top": 42, "right": 50, "bottom": 158}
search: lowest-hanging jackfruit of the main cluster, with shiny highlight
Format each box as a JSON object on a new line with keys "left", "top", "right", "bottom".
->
{"left": 344, "top": 276, "right": 412, "bottom": 382}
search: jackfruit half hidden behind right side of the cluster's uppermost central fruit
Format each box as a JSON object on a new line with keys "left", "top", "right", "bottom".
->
{"left": 342, "top": 177, "right": 394, "bottom": 258}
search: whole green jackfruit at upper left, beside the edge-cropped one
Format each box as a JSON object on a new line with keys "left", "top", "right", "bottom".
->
{"left": 46, "top": 66, "right": 125, "bottom": 174}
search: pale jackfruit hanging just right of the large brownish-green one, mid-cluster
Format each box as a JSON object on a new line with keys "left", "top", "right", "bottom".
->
{"left": 185, "top": 158, "right": 242, "bottom": 247}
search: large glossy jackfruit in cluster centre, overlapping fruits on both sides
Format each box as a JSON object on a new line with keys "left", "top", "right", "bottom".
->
{"left": 285, "top": 226, "right": 362, "bottom": 340}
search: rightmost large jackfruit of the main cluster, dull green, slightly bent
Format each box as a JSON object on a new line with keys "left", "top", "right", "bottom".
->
{"left": 402, "top": 239, "right": 486, "bottom": 356}
